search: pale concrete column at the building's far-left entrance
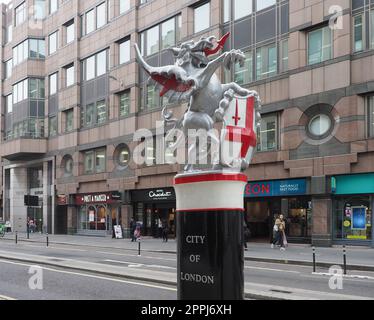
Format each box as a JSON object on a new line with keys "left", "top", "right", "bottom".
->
{"left": 9, "top": 168, "right": 27, "bottom": 232}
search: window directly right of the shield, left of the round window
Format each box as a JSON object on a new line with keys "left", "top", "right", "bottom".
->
{"left": 257, "top": 115, "right": 278, "bottom": 152}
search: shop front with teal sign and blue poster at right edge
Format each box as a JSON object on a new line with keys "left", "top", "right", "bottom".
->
{"left": 331, "top": 173, "right": 374, "bottom": 246}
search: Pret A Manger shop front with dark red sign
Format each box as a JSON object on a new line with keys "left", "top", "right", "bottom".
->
{"left": 75, "top": 191, "right": 122, "bottom": 236}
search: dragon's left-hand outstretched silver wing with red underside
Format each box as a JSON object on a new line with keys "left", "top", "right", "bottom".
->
{"left": 135, "top": 44, "right": 196, "bottom": 103}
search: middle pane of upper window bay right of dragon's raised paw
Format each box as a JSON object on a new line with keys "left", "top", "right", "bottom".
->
{"left": 256, "top": 44, "right": 277, "bottom": 80}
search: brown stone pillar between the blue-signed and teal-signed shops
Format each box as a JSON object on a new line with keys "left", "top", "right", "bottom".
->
{"left": 312, "top": 197, "right": 332, "bottom": 247}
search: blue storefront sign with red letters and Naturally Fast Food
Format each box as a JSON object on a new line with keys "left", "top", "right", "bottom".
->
{"left": 245, "top": 179, "right": 307, "bottom": 198}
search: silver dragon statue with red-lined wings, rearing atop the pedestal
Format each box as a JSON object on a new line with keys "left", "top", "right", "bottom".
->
{"left": 135, "top": 34, "right": 261, "bottom": 171}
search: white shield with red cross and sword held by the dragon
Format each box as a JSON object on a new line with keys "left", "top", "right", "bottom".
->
{"left": 221, "top": 95, "right": 257, "bottom": 167}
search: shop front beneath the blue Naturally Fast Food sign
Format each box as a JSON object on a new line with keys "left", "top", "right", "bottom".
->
{"left": 245, "top": 179, "right": 312, "bottom": 243}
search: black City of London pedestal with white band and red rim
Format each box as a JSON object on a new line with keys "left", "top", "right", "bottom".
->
{"left": 175, "top": 172, "right": 247, "bottom": 300}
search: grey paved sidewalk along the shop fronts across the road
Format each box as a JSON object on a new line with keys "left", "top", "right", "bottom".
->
{"left": 0, "top": 234, "right": 374, "bottom": 271}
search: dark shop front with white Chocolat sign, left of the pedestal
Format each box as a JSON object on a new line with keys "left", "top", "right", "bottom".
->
{"left": 131, "top": 188, "right": 176, "bottom": 238}
